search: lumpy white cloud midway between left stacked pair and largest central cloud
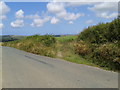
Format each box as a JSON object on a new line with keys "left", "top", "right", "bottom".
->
{"left": 31, "top": 16, "right": 50, "bottom": 27}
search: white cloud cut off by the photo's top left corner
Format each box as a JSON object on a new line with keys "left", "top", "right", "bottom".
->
{"left": 0, "top": 1, "right": 10, "bottom": 19}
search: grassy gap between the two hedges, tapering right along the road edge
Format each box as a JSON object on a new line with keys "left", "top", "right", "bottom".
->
{"left": 56, "top": 35, "right": 105, "bottom": 70}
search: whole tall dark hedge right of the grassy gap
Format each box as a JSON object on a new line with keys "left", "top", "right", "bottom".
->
{"left": 75, "top": 19, "right": 120, "bottom": 71}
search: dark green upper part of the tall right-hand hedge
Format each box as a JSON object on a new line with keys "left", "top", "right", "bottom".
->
{"left": 77, "top": 19, "right": 120, "bottom": 44}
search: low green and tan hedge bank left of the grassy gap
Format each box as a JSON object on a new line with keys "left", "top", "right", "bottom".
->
{"left": 3, "top": 35, "right": 56, "bottom": 57}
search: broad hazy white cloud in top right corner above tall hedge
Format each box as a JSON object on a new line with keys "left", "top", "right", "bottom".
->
{"left": 88, "top": 2, "right": 118, "bottom": 19}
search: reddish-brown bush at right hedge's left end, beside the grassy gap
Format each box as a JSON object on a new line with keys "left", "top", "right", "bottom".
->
{"left": 74, "top": 40, "right": 91, "bottom": 56}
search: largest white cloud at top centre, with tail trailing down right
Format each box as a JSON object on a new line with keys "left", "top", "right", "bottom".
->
{"left": 47, "top": 2, "right": 84, "bottom": 20}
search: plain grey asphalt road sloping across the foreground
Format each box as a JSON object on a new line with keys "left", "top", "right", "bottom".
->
{"left": 0, "top": 47, "right": 118, "bottom": 88}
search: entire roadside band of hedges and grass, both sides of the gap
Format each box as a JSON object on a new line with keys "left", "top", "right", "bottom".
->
{"left": 2, "top": 19, "right": 120, "bottom": 71}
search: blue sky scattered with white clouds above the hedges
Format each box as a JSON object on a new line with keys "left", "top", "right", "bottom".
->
{"left": 0, "top": 1, "right": 118, "bottom": 35}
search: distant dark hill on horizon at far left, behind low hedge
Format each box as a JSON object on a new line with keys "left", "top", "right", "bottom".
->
{"left": 0, "top": 35, "right": 25, "bottom": 42}
